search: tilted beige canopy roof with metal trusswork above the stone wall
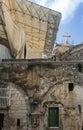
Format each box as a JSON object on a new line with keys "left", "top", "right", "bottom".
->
{"left": 0, "top": 0, "right": 61, "bottom": 58}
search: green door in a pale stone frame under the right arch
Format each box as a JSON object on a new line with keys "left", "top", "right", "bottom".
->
{"left": 48, "top": 107, "right": 59, "bottom": 127}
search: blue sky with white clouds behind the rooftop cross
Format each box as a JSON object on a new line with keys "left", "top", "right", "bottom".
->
{"left": 29, "top": 0, "right": 83, "bottom": 45}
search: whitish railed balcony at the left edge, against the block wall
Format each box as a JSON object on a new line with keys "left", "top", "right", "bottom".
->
{"left": 0, "top": 87, "right": 10, "bottom": 109}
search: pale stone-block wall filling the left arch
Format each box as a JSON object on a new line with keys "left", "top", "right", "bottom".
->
{"left": 0, "top": 83, "right": 28, "bottom": 130}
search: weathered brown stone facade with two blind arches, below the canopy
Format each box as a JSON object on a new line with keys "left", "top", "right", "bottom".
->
{"left": 0, "top": 60, "right": 83, "bottom": 130}
